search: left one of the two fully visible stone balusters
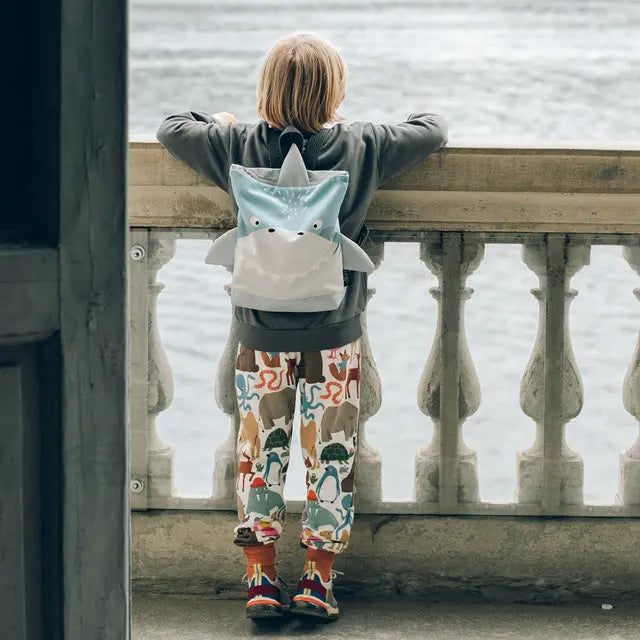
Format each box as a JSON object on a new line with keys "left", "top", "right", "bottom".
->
{"left": 414, "top": 233, "right": 484, "bottom": 512}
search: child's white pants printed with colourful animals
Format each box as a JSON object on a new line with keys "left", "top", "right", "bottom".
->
{"left": 234, "top": 339, "right": 360, "bottom": 553}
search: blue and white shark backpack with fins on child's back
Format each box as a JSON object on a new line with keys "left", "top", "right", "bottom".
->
{"left": 205, "top": 127, "right": 374, "bottom": 312}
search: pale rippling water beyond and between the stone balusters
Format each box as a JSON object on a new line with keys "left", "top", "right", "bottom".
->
{"left": 130, "top": 0, "right": 640, "bottom": 503}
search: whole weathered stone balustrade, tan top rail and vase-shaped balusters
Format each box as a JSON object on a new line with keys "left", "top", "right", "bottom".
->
{"left": 129, "top": 143, "right": 640, "bottom": 516}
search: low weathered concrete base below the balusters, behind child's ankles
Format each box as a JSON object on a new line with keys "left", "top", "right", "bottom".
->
{"left": 132, "top": 511, "right": 640, "bottom": 605}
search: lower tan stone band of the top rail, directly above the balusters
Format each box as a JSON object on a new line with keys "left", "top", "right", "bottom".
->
{"left": 129, "top": 185, "right": 640, "bottom": 234}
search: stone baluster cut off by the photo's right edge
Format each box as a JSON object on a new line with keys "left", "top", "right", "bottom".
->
{"left": 616, "top": 247, "right": 640, "bottom": 506}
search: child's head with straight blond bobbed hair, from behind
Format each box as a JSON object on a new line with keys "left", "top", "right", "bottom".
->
{"left": 258, "top": 33, "right": 347, "bottom": 133}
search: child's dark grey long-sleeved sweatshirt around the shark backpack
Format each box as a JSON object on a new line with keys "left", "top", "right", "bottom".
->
{"left": 157, "top": 111, "right": 447, "bottom": 351}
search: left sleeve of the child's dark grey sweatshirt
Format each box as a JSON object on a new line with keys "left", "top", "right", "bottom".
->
{"left": 156, "top": 111, "right": 246, "bottom": 191}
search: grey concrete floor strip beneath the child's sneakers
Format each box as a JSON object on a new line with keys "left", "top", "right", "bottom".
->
{"left": 133, "top": 595, "right": 640, "bottom": 640}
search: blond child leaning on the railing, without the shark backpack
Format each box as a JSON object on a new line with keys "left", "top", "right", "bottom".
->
{"left": 157, "top": 34, "right": 447, "bottom": 619}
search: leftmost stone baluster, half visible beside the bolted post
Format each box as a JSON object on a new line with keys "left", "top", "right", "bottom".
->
{"left": 147, "top": 231, "right": 176, "bottom": 496}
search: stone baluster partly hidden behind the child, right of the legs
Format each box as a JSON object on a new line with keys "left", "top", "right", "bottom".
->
{"left": 354, "top": 239, "right": 384, "bottom": 511}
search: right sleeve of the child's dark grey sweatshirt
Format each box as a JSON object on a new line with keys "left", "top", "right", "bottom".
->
{"left": 371, "top": 113, "right": 448, "bottom": 186}
